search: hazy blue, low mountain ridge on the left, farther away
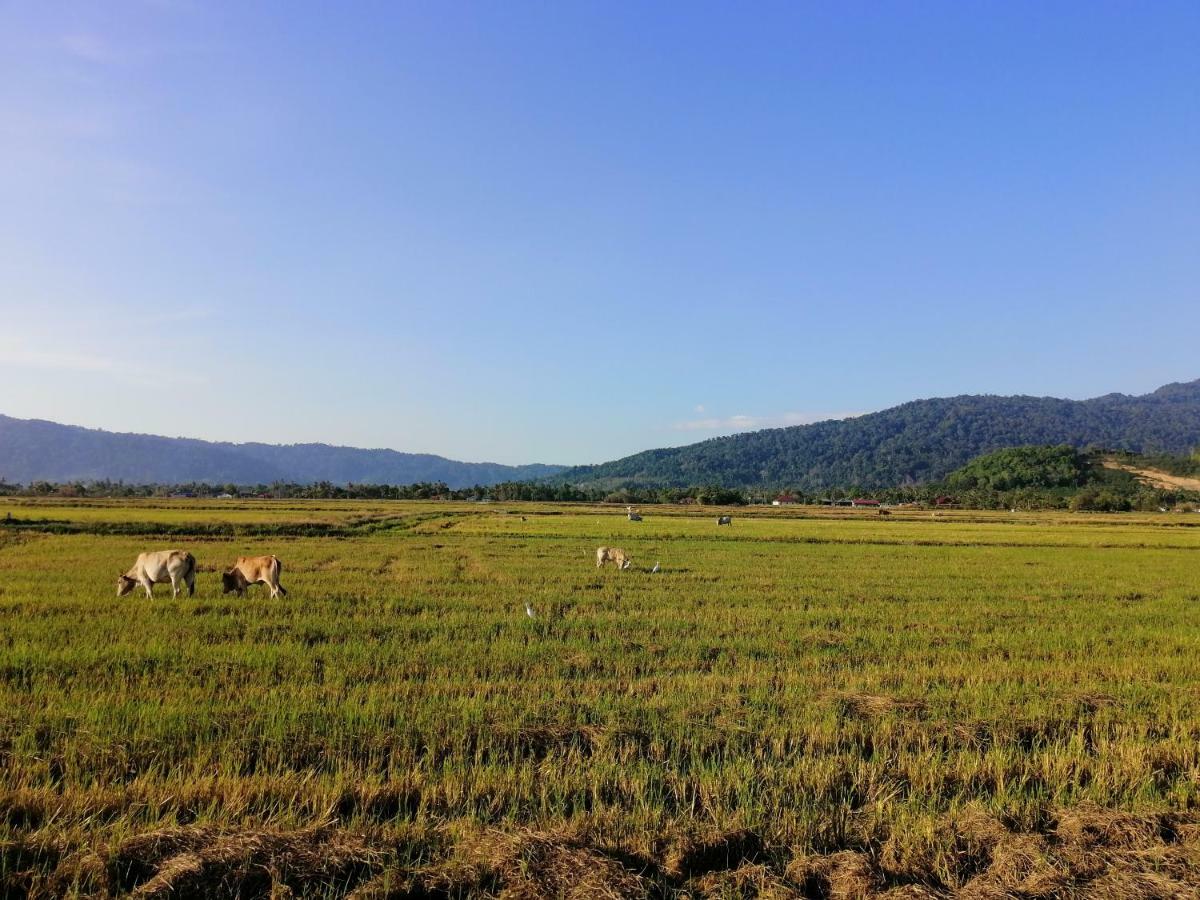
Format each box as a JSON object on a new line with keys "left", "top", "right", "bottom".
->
{"left": 0, "top": 415, "right": 564, "bottom": 487}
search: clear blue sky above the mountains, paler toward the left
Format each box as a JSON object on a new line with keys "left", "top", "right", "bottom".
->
{"left": 0, "top": 0, "right": 1200, "bottom": 463}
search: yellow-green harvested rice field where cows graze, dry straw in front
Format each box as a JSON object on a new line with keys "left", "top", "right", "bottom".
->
{"left": 0, "top": 502, "right": 1200, "bottom": 898}
